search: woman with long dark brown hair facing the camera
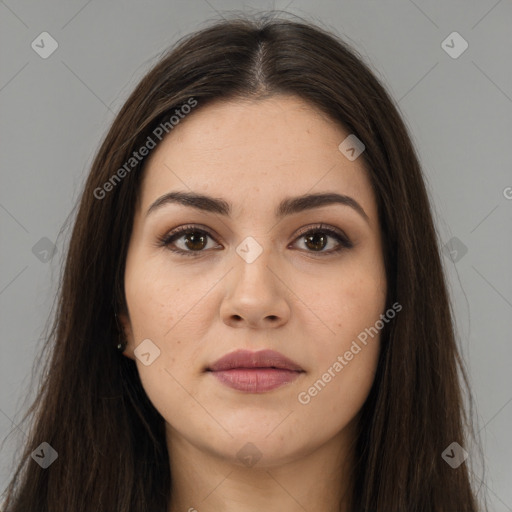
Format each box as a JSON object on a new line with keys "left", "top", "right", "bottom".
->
{"left": 1, "top": 14, "right": 477, "bottom": 512}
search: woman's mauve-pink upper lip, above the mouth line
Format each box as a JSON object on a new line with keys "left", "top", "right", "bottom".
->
{"left": 206, "top": 350, "right": 304, "bottom": 372}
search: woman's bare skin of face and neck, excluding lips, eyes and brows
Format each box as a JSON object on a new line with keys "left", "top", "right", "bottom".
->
{"left": 120, "top": 95, "right": 387, "bottom": 512}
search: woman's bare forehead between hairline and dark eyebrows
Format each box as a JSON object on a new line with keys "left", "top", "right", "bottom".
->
{"left": 136, "top": 95, "right": 375, "bottom": 222}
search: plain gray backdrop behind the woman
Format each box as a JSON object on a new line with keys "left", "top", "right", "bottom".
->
{"left": 0, "top": 0, "right": 512, "bottom": 511}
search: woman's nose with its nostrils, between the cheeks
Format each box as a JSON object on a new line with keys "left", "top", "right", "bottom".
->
{"left": 220, "top": 249, "right": 290, "bottom": 329}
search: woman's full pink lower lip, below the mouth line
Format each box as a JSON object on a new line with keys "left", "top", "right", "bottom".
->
{"left": 211, "top": 368, "right": 303, "bottom": 393}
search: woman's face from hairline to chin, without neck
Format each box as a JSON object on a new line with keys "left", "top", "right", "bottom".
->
{"left": 118, "top": 95, "right": 386, "bottom": 467}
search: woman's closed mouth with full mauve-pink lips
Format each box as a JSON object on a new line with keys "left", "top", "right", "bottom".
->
{"left": 205, "top": 350, "right": 305, "bottom": 393}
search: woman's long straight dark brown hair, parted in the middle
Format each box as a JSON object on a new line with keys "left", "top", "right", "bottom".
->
{"left": 1, "top": 16, "right": 484, "bottom": 512}
